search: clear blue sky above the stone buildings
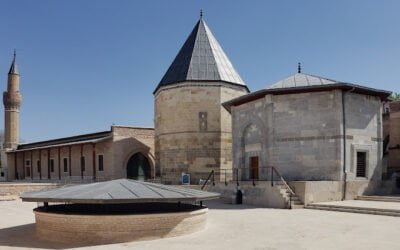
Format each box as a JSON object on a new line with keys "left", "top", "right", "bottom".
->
{"left": 0, "top": 0, "right": 400, "bottom": 141}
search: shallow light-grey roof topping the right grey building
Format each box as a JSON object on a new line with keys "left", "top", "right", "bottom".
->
{"left": 266, "top": 73, "right": 339, "bottom": 89}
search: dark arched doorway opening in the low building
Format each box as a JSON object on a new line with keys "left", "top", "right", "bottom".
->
{"left": 126, "top": 153, "right": 151, "bottom": 181}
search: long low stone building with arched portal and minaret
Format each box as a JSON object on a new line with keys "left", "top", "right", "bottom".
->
{"left": 0, "top": 53, "right": 155, "bottom": 181}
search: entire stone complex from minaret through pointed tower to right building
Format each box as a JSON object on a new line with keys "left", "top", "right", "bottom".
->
{"left": 0, "top": 16, "right": 390, "bottom": 201}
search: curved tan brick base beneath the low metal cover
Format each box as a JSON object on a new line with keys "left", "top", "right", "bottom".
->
{"left": 34, "top": 208, "right": 208, "bottom": 245}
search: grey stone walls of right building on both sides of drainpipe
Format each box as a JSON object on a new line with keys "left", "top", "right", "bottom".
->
{"left": 232, "top": 90, "right": 382, "bottom": 181}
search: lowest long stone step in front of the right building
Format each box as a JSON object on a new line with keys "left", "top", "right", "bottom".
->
{"left": 305, "top": 204, "right": 400, "bottom": 217}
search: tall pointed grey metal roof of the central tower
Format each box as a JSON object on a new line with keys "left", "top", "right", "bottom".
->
{"left": 155, "top": 18, "right": 246, "bottom": 91}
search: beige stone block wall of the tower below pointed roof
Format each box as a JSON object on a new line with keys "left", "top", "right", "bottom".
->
{"left": 154, "top": 82, "right": 247, "bottom": 184}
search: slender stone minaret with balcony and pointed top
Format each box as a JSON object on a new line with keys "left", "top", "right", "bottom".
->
{"left": 3, "top": 50, "right": 22, "bottom": 149}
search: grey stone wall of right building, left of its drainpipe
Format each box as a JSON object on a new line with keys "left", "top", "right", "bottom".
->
{"left": 233, "top": 91, "right": 341, "bottom": 180}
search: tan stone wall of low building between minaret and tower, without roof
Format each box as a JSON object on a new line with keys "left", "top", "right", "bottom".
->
{"left": 7, "top": 126, "right": 155, "bottom": 181}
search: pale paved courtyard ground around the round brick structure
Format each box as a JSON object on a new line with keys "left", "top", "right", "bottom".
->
{"left": 0, "top": 200, "right": 400, "bottom": 250}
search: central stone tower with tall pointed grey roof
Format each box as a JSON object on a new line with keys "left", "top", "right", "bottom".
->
{"left": 154, "top": 17, "right": 249, "bottom": 183}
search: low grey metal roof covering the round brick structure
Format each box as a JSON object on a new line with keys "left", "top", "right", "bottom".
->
{"left": 21, "top": 179, "right": 220, "bottom": 204}
